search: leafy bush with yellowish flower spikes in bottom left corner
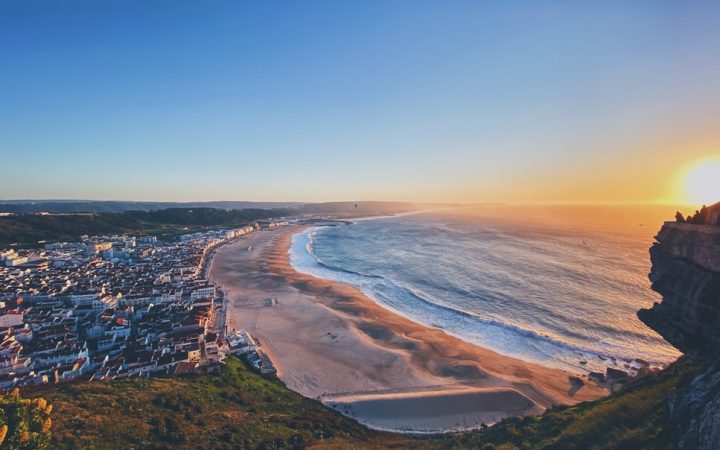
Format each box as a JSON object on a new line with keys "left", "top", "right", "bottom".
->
{"left": 0, "top": 389, "right": 52, "bottom": 450}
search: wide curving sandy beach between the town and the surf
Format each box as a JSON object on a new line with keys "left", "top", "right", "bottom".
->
{"left": 210, "top": 226, "right": 607, "bottom": 432}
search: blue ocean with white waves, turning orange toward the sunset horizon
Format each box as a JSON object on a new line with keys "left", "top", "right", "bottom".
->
{"left": 290, "top": 206, "right": 679, "bottom": 372}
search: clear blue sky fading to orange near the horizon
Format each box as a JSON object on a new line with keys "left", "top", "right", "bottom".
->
{"left": 0, "top": 0, "right": 720, "bottom": 203}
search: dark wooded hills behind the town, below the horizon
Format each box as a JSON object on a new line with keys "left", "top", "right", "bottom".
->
{"left": 0, "top": 208, "right": 290, "bottom": 248}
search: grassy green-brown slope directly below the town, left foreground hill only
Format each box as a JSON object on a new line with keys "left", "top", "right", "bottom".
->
{"left": 29, "top": 357, "right": 410, "bottom": 449}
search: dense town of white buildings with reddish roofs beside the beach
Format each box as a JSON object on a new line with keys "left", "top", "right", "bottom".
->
{"left": 0, "top": 221, "right": 288, "bottom": 389}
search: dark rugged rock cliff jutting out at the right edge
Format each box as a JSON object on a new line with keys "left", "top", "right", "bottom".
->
{"left": 638, "top": 223, "right": 720, "bottom": 449}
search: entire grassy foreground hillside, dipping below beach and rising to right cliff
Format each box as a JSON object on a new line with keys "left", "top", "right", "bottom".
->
{"left": 21, "top": 358, "right": 696, "bottom": 450}
